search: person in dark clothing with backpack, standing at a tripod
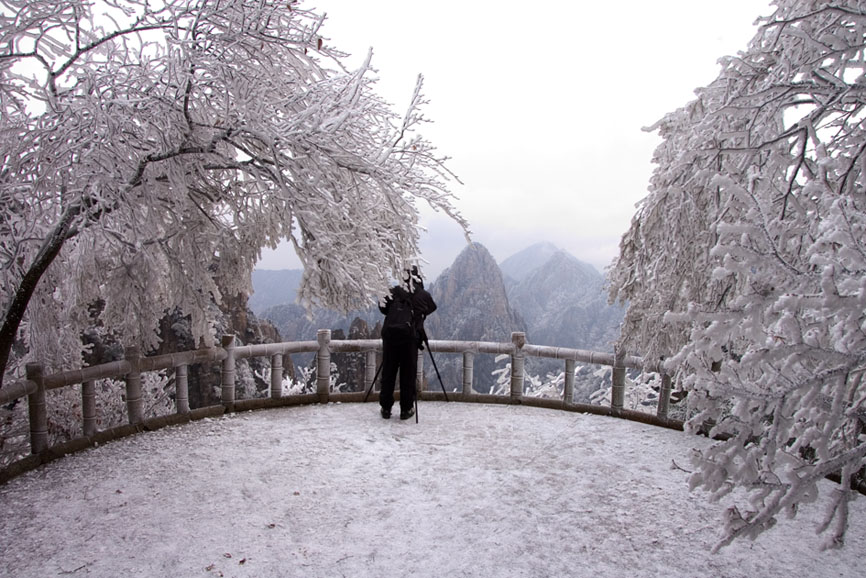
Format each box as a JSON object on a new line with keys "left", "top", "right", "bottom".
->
{"left": 379, "top": 267, "right": 436, "bottom": 420}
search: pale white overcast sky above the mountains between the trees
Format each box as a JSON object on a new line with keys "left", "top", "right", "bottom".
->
{"left": 259, "top": 0, "right": 772, "bottom": 279}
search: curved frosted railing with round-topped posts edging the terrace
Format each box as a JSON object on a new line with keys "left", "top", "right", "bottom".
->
{"left": 0, "top": 329, "right": 682, "bottom": 483}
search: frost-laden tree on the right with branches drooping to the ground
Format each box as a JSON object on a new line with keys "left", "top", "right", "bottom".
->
{"left": 610, "top": 0, "right": 866, "bottom": 545}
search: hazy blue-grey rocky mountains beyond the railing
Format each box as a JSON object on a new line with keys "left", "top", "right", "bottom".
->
{"left": 249, "top": 243, "right": 623, "bottom": 392}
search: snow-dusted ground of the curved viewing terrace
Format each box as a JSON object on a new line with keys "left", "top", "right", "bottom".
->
{"left": 0, "top": 402, "right": 866, "bottom": 578}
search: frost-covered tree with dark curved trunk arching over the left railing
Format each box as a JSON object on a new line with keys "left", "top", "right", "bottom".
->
{"left": 0, "top": 0, "right": 466, "bottom": 384}
